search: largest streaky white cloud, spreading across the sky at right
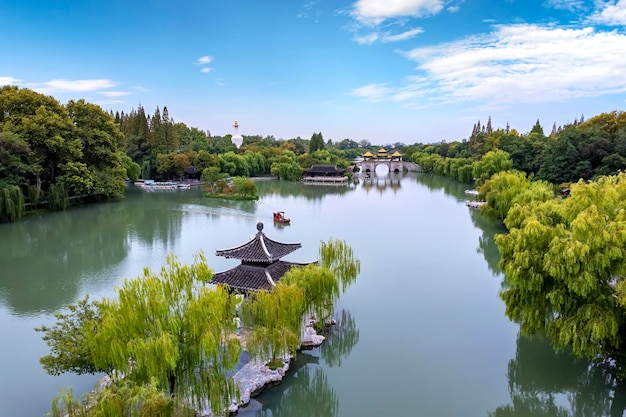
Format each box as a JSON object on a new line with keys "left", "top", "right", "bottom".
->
{"left": 351, "top": 24, "right": 626, "bottom": 106}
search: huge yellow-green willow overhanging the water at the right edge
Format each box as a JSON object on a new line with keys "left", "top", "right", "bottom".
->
{"left": 497, "top": 173, "right": 626, "bottom": 377}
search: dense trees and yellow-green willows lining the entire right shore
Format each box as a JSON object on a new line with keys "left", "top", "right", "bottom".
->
{"left": 413, "top": 111, "right": 626, "bottom": 386}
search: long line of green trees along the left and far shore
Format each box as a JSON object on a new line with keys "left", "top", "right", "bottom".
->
{"left": 0, "top": 86, "right": 369, "bottom": 222}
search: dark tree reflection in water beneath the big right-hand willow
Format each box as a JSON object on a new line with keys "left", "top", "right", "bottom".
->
{"left": 489, "top": 335, "right": 626, "bottom": 417}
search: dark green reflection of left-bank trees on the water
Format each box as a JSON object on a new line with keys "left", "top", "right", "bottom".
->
{"left": 0, "top": 203, "right": 130, "bottom": 316}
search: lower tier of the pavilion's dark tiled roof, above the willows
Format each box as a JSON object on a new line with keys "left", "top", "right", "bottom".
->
{"left": 211, "top": 261, "right": 306, "bottom": 292}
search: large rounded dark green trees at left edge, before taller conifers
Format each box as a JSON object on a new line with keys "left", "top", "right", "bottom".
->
{"left": 0, "top": 87, "right": 126, "bottom": 216}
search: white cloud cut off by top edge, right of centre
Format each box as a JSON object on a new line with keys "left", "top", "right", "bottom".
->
{"left": 351, "top": 0, "right": 444, "bottom": 25}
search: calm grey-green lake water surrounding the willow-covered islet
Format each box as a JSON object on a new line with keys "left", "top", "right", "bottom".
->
{"left": 0, "top": 174, "right": 623, "bottom": 417}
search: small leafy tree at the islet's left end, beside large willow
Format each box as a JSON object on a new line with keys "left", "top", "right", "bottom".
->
{"left": 35, "top": 296, "right": 102, "bottom": 375}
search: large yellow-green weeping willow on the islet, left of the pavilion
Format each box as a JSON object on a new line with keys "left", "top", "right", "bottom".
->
{"left": 85, "top": 254, "right": 241, "bottom": 412}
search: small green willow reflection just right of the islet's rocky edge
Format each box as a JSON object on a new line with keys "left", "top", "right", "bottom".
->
{"left": 320, "top": 310, "right": 359, "bottom": 367}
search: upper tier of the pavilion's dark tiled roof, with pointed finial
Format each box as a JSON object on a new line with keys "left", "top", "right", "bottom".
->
{"left": 215, "top": 223, "right": 302, "bottom": 264}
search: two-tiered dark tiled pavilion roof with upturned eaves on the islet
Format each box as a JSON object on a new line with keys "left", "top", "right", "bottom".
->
{"left": 211, "top": 222, "right": 308, "bottom": 293}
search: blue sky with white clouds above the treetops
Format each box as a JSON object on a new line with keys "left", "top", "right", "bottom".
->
{"left": 0, "top": 0, "right": 626, "bottom": 144}
